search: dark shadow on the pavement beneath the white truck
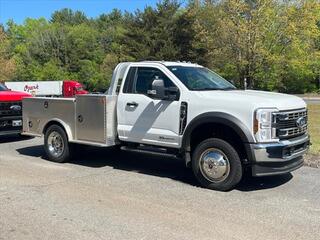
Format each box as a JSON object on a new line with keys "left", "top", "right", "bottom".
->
{"left": 17, "top": 145, "right": 292, "bottom": 192}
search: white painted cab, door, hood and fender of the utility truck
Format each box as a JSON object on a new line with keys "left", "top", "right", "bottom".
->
{"left": 116, "top": 62, "right": 306, "bottom": 148}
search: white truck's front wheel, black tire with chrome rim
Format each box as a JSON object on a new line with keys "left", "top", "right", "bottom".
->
{"left": 192, "top": 138, "right": 242, "bottom": 191}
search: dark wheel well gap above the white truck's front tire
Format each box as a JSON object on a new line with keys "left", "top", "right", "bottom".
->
{"left": 190, "top": 123, "right": 248, "bottom": 160}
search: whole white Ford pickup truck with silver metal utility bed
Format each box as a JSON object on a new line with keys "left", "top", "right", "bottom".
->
{"left": 23, "top": 61, "right": 310, "bottom": 191}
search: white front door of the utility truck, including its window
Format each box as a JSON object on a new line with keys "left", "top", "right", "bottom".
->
{"left": 117, "top": 67, "right": 180, "bottom": 147}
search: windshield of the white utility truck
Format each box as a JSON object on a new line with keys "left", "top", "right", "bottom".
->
{"left": 168, "top": 66, "right": 236, "bottom": 91}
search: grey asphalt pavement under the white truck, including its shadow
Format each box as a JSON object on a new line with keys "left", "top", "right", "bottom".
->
{"left": 0, "top": 137, "right": 320, "bottom": 240}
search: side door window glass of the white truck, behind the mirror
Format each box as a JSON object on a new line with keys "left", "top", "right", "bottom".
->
{"left": 131, "top": 67, "right": 174, "bottom": 94}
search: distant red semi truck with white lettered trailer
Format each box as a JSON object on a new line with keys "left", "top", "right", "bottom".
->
{"left": 5, "top": 80, "right": 88, "bottom": 97}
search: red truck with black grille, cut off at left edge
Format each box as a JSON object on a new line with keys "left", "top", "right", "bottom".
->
{"left": 0, "top": 83, "right": 31, "bottom": 135}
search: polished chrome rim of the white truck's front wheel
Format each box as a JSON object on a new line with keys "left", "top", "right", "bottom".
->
{"left": 199, "top": 148, "right": 230, "bottom": 183}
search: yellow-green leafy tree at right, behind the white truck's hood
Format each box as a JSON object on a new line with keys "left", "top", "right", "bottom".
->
{"left": 188, "top": 0, "right": 319, "bottom": 92}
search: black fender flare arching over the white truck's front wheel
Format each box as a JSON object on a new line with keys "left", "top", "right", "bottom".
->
{"left": 182, "top": 112, "right": 255, "bottom": 152}
